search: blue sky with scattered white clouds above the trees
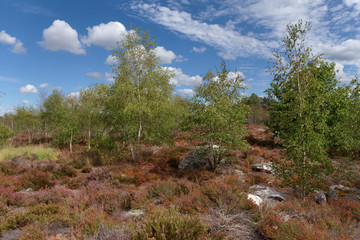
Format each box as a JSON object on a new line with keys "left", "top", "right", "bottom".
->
{"left": 0, "top": 0, "right": 360, "bottom": 115}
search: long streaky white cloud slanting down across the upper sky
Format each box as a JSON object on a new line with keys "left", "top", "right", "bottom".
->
{"left": 132, "top": 4, "right": 273, "bottom": 59}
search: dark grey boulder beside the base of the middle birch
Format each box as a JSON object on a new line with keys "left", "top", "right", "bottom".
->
{"left": 178, "top": 150, "right": 212, "bottom": 170}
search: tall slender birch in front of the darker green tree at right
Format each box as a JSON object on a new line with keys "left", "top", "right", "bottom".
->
{"left": 267, "top": 21, "right": 331, "bottom": 198}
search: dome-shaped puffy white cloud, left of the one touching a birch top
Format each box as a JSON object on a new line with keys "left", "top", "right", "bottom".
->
{"left": 38, "top": 20, "right": 85, "bottom": 54}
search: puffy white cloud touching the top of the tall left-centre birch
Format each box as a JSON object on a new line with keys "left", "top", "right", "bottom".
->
{"left": 81, "top": 22, "right": 126, "bottom": 50}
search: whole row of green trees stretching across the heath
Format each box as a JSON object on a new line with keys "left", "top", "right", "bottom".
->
{"left": 0, "top": 21, "right": 360, "bottom": 196}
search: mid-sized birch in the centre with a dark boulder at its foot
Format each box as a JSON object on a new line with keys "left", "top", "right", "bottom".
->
{"left": 190, "top": 61, "right": 250, "bottom": 169}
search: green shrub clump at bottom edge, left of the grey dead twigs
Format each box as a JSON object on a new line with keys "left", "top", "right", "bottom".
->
{"left": 132, "top": 208, "right": 206, "bottom": 240}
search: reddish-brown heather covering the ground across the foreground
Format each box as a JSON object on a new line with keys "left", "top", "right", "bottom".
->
{"left": 0, "top": 125, "right": 360, "bottom": 240}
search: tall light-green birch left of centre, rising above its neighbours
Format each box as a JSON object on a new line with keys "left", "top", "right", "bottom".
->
{"left": 107, "top": 29, "right": 175, "bottom": 161}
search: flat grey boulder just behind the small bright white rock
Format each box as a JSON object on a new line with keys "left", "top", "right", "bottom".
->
{"left": 250, "top": 185, "right": 288, "bottom": 205}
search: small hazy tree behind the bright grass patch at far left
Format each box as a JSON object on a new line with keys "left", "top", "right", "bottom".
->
{"left": 14, "top": 106, "right": 40, "bottom": 143}
